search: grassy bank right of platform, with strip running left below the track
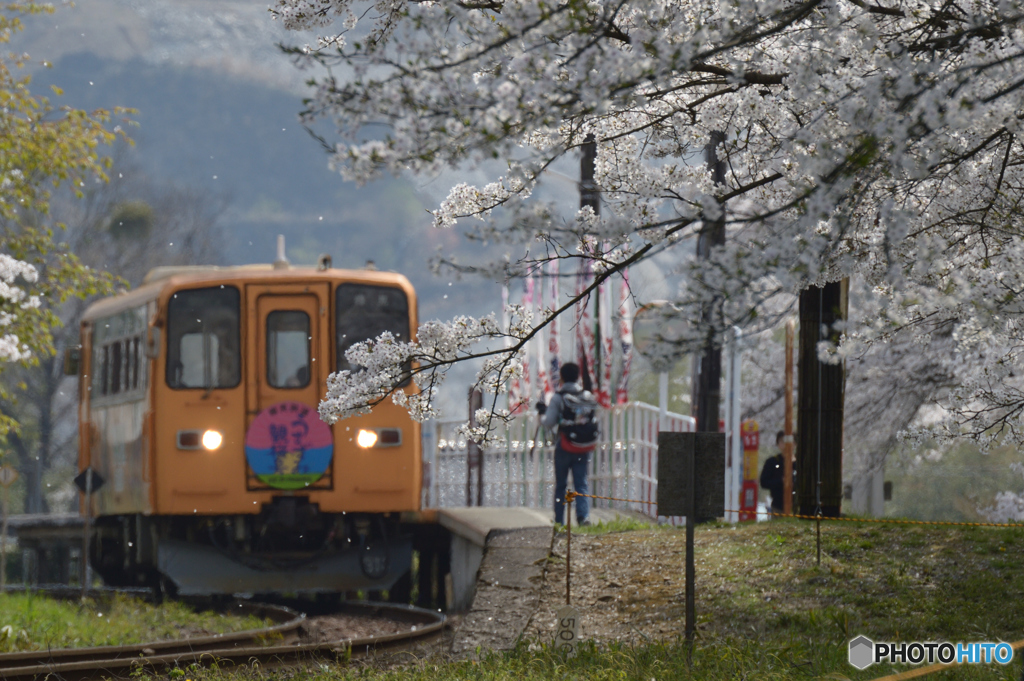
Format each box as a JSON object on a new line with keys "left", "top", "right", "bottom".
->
{"left": 117, "top": 520, "right": 1024, "bottom": 681}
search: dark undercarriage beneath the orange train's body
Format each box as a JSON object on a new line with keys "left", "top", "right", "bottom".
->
{"left": 89, "top": 496, "right": 424, "bottom": 600}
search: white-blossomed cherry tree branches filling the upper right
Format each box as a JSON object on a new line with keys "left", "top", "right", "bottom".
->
{"left": 271, "top": 0, "right": 1024, "bottom": 439}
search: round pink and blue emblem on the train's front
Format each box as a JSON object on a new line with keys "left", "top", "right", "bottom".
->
{"left": 246, "top": 401, "right": 334, "bottom": 490}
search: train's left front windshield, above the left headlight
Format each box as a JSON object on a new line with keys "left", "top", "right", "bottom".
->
{"left": 167, "top": 286, "right": 242, "bottom": 388}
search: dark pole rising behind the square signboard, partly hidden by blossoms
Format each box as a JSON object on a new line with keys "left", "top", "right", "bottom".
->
{"left": 690, "top": 131, "right": 725, "bottom": 433}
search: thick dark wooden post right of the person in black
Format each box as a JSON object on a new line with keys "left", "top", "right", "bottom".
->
{"left": 797, "top": 279, "right": 850, "bottom": 517}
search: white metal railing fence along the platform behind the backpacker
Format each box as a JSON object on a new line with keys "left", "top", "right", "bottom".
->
{"left": 423, "top": 402, "right": 695, "bottom": 516}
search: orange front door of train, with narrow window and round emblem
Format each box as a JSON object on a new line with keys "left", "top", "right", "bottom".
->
{"left": 246, "top": 284, "right": 333, "bottom": 490}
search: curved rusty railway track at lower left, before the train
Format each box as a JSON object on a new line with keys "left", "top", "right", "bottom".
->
{"left": 0, "top": 602, "right": 444, "bottom": 681}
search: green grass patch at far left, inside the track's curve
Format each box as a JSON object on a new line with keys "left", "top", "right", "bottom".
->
{"left": 0, "top": 593, "right": 271, "bottom": 652}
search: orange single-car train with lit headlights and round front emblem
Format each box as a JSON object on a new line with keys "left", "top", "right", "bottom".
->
{"left": 66, "top": 260, "right": 422, "bottom": 594}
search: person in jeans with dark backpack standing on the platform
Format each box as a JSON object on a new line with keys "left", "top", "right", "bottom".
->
{"left": 537, "top": 361, "right": 597, "bottom": 526}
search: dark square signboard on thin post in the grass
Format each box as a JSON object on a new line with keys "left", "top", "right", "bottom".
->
{"left": 657, "top": 432, "right": 725, "bottom": 519}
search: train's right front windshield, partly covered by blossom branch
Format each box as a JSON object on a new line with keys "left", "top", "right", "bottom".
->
{"left": 335, "top": 284, "right": 410, "bottom": 378}
